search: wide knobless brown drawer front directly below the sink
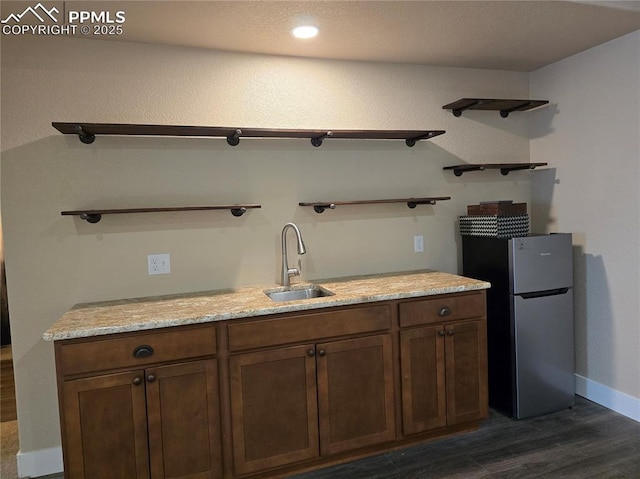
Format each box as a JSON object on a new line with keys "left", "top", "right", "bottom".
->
{"left": 229, "top": 304, "right": 391, "bottom": 351}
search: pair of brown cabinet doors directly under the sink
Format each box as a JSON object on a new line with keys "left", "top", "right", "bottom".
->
{"left": 229, "top": 332, "right": 395, "bottom": 475}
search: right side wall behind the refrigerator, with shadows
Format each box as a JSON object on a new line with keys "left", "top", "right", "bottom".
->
{"left": 531, "top": 32, "right": 640, "bottom": 399}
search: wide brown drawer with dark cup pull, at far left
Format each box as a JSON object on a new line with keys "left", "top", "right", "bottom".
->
{"left": 56, "top": 325, "right": 216, "bottom": 375}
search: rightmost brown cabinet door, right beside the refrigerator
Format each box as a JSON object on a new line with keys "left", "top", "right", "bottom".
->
{"left": 445, "top": 321, "right": 489, "bottom": 425}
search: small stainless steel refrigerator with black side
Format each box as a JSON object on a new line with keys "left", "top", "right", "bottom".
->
{"left": 462, "top": 233, "right": 575, "bottom": 418}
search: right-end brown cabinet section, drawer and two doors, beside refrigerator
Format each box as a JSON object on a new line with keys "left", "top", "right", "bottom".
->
{"left": 400, "top": 294, "right": 488, "bottom": 435}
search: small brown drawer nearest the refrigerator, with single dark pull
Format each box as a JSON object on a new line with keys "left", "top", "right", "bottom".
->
{"left": 399, "top": 291, "right": 486, "bottom": 328}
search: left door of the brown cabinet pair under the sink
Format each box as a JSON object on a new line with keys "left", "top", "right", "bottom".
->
{"left": 229, "top": 345, "right": 318, "bottom": 475}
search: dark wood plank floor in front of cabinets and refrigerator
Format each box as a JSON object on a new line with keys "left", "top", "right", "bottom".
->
{"left": 291, "top": 396, "right": 640, "bottom": 479}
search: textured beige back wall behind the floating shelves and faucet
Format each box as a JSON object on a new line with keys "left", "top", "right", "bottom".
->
{"left": 1, "top": 37, "right": 535, "bottom": 473}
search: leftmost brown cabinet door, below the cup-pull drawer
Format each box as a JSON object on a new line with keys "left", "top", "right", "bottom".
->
{"left": 62, "top": 371, "right": 149, "bottom": 479}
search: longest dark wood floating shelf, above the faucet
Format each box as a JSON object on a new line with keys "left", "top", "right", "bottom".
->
{"left": 51, "top": 122, "right": 445, "bottom": 147}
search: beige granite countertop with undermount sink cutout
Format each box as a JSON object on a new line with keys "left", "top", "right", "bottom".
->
{"left": 43, "top": 270, "right": 490, "bottom": 341}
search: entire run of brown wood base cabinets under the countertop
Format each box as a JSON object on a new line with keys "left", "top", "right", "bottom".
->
{"left": 55, "top": 291, "right": 488, "bottom": 479}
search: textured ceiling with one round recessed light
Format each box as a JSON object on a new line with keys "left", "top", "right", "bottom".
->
{"left": 2, "top": 0, "right": 640, "bottom": 72}
